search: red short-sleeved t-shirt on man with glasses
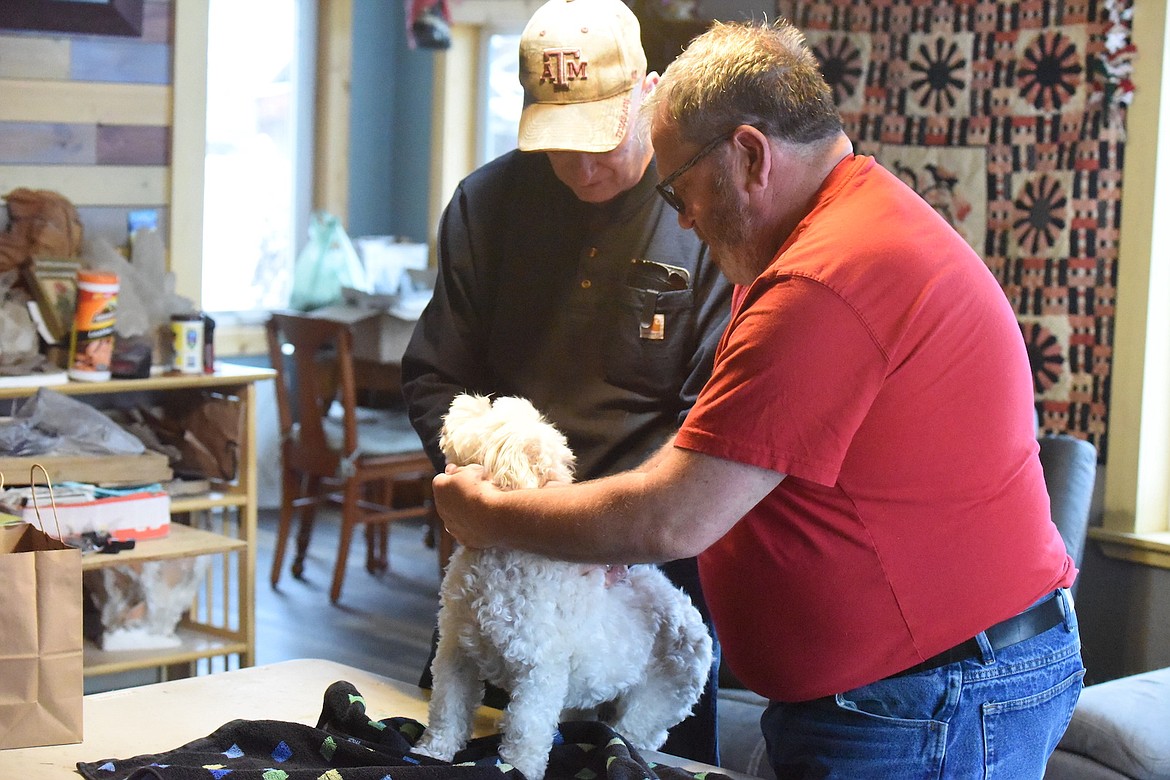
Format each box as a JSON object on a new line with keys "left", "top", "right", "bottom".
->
{"left": 676, "top": 157, "right": 1075, "bottom": 702}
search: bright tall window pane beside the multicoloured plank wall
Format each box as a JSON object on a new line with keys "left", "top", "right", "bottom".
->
{"left": 201, "top": 0, "right": 315, "bottom": 313}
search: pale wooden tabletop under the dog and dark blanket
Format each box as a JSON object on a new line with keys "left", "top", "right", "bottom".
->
{"left": 0, "top": 658, "right": 758, "bottom": 780}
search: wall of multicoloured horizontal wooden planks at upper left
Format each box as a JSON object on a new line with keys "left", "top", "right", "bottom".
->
{"left": 0, "top": 0, "right": 174, "bottom": 247}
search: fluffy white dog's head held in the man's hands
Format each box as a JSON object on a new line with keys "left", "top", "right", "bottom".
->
{"left": 439, "top": 393, "right": 574, "bottom": 490}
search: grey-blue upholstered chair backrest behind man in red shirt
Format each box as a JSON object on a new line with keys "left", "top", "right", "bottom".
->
{"left": 1040, "top": 434, "right": 1097, "bottom": 584}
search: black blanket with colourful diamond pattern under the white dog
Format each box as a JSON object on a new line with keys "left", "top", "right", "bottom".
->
{"left": 77, "top": 681, "right": 720, "bottom": 780}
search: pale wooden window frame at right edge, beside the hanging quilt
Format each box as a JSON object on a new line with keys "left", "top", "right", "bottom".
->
{"left": 1089, "top": 0, "right": 1170, "bottom": 568}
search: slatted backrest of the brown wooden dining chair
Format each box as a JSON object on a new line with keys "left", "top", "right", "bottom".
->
{"left": 267, "top": 312, "right": 358, "bottom": 476}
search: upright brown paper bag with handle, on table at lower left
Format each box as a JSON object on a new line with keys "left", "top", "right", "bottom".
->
{"left": 0, "top": 523, "right": 85, "bottom": 748}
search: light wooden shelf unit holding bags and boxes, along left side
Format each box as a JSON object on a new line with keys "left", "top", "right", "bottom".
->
{"left": 0, "top": 364, "right": 275, "bottom": 678}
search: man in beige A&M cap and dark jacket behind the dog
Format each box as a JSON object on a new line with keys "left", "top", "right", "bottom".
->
{"left": 402, "top": 0, "right": 730, "bottom": 765}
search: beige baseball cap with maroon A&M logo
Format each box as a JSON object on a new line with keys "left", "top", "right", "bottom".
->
{"left": 519, "top": 0, "right": 646, "bottom": 152}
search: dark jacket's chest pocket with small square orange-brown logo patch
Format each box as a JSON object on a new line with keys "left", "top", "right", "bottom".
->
{"left": 605, "top": 285, "right": 695, "bottom": 396}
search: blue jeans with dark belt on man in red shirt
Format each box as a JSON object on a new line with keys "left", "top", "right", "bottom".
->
{"left": 761, "top": 591, "right": 1085, "bottom": 780}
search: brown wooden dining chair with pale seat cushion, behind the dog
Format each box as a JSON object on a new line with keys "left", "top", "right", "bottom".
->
{"left": 267, "top": 312, "right": 453, "bottom": 603}
